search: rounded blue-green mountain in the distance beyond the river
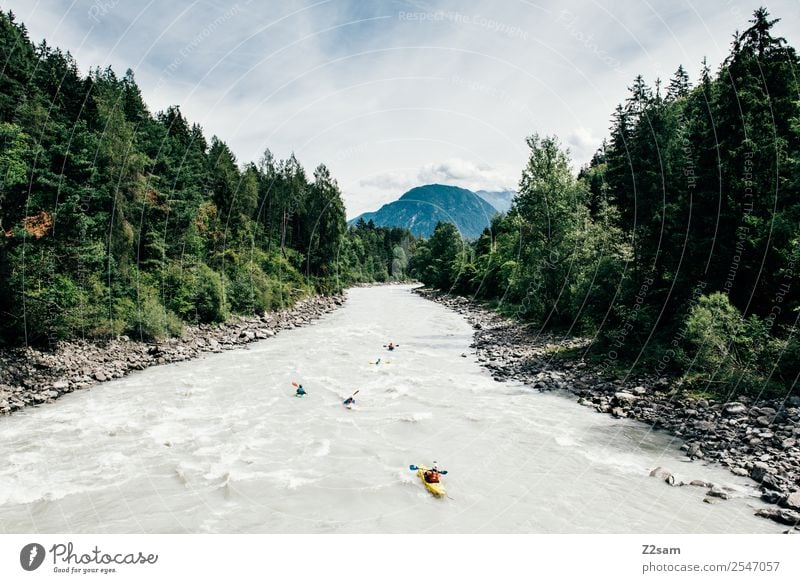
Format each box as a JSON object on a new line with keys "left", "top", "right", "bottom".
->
{"left": 349, "top": 184, "right": 497, "bottom": 239}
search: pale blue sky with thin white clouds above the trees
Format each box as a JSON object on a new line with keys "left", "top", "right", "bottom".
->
{"left": 0, "top": 0, "right": 800, "bottom": 217}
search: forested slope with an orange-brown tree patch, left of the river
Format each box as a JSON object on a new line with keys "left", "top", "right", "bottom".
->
{"left": 0, "top": 13, "right": 412, "bottom": 345}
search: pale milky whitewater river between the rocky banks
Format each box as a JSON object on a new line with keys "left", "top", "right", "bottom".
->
{"left": 0, "top": 286, "right": 781, "bottom": 533}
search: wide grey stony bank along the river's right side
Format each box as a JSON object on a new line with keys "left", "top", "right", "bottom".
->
{"left": 415, "top": 288, "right": 800, "bottom": 530}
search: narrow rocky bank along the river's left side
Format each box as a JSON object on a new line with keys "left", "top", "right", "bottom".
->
{"left": 0, "top": 296, "right": 344, "bottom": 415}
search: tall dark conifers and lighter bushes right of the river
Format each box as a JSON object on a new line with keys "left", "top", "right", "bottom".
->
{"left": 412, "top": 9, "right": 800, "bottom": 394}
